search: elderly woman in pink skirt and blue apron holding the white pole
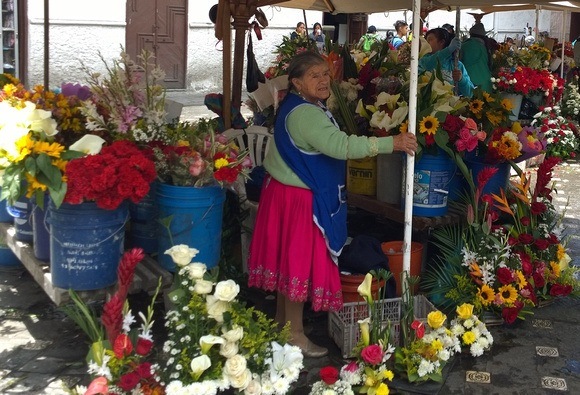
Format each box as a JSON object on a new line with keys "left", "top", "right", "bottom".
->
{"left": 248, "top": 51, "right": 417, "bottom": 357}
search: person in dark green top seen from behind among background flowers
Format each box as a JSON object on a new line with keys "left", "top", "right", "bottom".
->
{"left": 459, "top": 23, "right": 493, "bottom": 92}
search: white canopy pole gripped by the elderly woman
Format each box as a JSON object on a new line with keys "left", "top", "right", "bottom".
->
{"left": 402, "top": 0, "right": 421, "bottom": 303}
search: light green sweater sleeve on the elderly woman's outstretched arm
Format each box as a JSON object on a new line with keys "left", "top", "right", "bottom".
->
{"left": 287, "top": 105, "right": 393, "bottom": 159}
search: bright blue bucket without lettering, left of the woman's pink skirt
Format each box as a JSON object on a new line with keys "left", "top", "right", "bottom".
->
{"left": 157, "top": 184, "right": 226, "bottom": 271}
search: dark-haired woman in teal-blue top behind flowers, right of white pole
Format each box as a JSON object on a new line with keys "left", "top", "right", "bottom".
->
{"left": 419, "top": 27, "right": 474, "bottom": 97}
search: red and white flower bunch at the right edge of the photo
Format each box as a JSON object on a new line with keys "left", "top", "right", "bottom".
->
{"left": 532, "top": 106, "right": 580, "bottom": 160}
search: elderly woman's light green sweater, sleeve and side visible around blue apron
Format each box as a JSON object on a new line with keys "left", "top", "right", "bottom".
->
{"left": 264, "top": 102, "right": 393, "bottom": 188}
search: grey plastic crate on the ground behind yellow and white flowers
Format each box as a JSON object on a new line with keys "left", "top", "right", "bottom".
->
{"left": 328, "top": 295, "right": 436, "bottom": 358}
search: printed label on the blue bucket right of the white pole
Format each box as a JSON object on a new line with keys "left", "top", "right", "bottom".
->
{"left": 413, "top": 170, "right": 450, "bottom": 208}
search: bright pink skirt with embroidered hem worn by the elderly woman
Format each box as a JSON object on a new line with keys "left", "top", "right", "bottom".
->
{"left": 248, "top": 177, "right": 342, "bottom": 311}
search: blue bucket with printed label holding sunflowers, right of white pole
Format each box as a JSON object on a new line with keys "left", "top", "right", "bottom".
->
{"left": 413, "top": 152, "right": 456, "bottom": 217}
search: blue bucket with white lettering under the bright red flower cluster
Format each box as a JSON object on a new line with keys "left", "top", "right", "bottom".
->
{"left": 47, "top": 201, "right": 129, "bottom": 291}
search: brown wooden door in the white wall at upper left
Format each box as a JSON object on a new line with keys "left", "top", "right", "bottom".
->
{"left": 125, "top": 0, "right": 187, "bottom": 89}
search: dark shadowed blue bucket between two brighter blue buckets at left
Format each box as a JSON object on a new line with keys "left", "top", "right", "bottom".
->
{"left": 126, "top": 183, "right": 158, "bottom": 254}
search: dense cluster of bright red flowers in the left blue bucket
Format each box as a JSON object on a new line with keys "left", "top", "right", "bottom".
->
{"left": 64, "top": 140, "right": 156, "bottom": 210}
